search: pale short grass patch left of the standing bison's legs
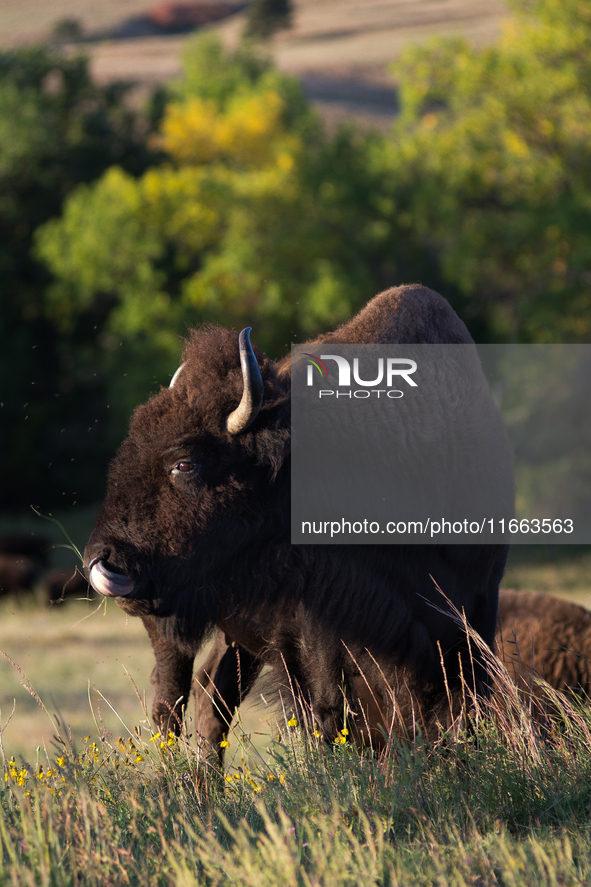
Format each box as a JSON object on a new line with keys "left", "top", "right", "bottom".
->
{"left": 0, "top": 600, "right": 153, "bottom": 760}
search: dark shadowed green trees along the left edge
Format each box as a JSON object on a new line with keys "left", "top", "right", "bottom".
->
{"left": 0, "top": 47, "right": 160, "bottom": 507}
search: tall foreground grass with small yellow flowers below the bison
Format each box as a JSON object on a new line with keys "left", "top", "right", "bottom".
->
{"left": 0, "top": 638, "right": 591, "bottom": 887}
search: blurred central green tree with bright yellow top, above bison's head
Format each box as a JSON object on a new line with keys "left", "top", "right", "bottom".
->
{"left": 38, "top": 37, "right": 392, "bottom": 411}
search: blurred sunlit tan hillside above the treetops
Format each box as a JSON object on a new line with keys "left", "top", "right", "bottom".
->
{"left": 0, "top": 0, "right": 507, "bottom": 128}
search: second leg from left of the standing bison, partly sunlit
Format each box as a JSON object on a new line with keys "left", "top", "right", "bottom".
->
{"left": 193, "top": 629, "right": 262, "bottom": 766}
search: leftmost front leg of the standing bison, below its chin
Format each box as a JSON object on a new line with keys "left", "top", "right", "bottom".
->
{"left": 142, "top": 616, "right": 195, "bottom": 735}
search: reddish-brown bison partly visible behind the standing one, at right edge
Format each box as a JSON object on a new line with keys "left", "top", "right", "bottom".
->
{"left": 497, "top": 589, "right": 591, "bottom": 696}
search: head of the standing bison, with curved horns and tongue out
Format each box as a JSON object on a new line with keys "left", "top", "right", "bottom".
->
{"left": 85, "top": 327, "right": 289, "bottom": 643}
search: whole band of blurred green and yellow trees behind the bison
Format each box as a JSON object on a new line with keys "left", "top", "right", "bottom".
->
{"left": 0, "top": 0, "right": 591, "bottom": 502}
